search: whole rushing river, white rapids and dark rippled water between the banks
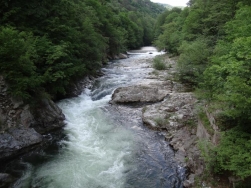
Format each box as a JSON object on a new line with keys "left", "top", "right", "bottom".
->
{"left": 8, "top": 46, "right": 185, "bottom": 188}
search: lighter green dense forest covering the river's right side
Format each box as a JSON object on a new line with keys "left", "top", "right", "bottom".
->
{"left": 154, "top": 0, "right": 251, "bottom": 185}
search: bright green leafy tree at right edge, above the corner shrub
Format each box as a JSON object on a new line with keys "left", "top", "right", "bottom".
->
{"left": 203, "top": 7, "right": 251, "bottom": 122}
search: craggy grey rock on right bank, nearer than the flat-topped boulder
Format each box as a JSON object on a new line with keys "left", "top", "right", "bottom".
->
{"left": 142, "top": 92, "right": 204, "bottom": 187}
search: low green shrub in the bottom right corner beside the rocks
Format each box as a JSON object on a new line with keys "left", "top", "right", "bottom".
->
{"left": 198, "top": 127, "right": 251, "bottom": 179}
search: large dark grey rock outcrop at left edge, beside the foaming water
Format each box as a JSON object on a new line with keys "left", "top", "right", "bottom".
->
{"left": 0, "top": 75, "right": 64, "bottom": 161}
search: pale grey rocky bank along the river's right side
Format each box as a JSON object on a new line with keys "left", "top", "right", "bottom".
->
{"left": 110, "top": 53, "right": 205, "bottom": 187}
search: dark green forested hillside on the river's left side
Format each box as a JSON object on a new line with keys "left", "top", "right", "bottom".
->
{"left": 0, "top": 0, "right": 165, "bottom": 100}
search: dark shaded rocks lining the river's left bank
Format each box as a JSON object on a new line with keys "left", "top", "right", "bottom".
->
{"left": 0, "top": 54, "right": 127, "bottom": 187}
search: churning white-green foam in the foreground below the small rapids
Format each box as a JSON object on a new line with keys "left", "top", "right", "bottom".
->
{"left": 24, "top": 90, "right": 134, "bottom": 188}
